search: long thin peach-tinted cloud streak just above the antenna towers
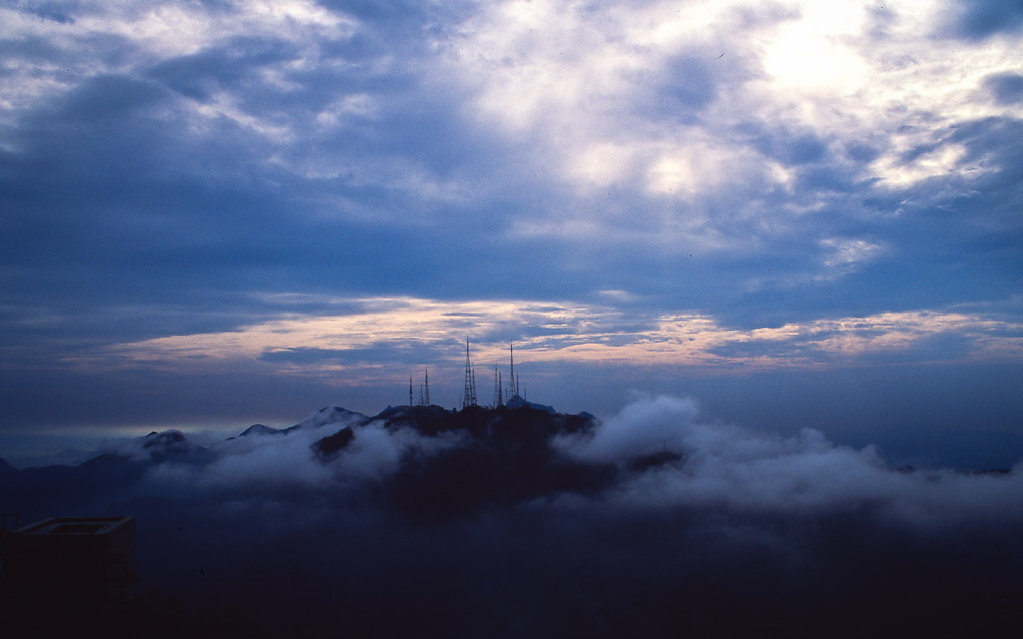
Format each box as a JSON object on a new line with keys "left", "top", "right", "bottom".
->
{"left": 65, "top": 294, "right": 1023, "bottom": 378}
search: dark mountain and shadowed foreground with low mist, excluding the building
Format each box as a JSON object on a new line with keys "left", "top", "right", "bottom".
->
{"left": 0, "top": 398, "right": 1023, "bottom": 637}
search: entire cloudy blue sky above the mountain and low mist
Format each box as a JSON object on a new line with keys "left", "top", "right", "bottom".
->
{"left": 0, "top": 0, "right": 1023, "bottom": 467}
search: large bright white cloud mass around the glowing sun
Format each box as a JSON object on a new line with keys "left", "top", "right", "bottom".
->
{"left": 438, "top": 0, "right": 1021, "bottom": 245}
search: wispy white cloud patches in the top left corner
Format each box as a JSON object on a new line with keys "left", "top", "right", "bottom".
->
{"left": 0, "top": 0, "right": 358, "bottom": 140}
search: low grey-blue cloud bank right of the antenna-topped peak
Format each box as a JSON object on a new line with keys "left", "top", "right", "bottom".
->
{"left": 554, "top": 396, "right": 1023, "bottom": 531}
